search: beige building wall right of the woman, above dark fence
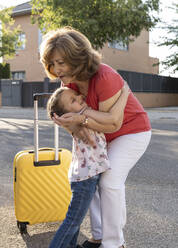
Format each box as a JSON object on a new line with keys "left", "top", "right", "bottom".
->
{"left": 101, "top": 31, "right": 159, "bottom": 74}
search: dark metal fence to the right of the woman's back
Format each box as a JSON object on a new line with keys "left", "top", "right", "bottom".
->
{"left": 118, "top": 70, "right": 178, "bottom": 93}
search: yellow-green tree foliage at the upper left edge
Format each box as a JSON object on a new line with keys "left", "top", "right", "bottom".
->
{"left": 0, "top": 8, "right": 21, "bottom": 58}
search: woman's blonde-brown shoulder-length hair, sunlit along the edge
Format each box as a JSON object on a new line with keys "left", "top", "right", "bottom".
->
{"left": 40, "top": 27, "right": 101, "bottom": 81}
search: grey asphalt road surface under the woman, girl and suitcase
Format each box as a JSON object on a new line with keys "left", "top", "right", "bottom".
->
{"left": 0, "top": 107, "right": 178, "bottom": 248}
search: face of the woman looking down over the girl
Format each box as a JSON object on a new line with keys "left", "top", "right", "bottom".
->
{"left": 49, "top": 50, "right": 74, "bottom": 85}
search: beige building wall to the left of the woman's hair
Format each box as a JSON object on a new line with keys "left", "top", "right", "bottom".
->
{"left": 8, "top": 15, "right": 46, "bottom": 81}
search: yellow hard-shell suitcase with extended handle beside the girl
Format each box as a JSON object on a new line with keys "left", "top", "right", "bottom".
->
{"left": 13, "top": 93, "right": 72, "bottom": 233}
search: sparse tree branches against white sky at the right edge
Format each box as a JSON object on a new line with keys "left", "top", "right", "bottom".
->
{"left": 158, "top": 4, "right": 178, "bottom": 73}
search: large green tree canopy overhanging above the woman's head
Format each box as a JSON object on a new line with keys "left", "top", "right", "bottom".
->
{"left": 32, "top": 0, "right": 159, "bottom": 48}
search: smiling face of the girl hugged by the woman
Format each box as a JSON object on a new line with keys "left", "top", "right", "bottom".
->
{"left": 61, "top": 89, "right": 87, "bottom": 113}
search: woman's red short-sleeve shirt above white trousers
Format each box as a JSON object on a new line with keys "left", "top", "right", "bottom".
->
{"left": 68, "top": 64, "right": 151, "bottom": 142}
